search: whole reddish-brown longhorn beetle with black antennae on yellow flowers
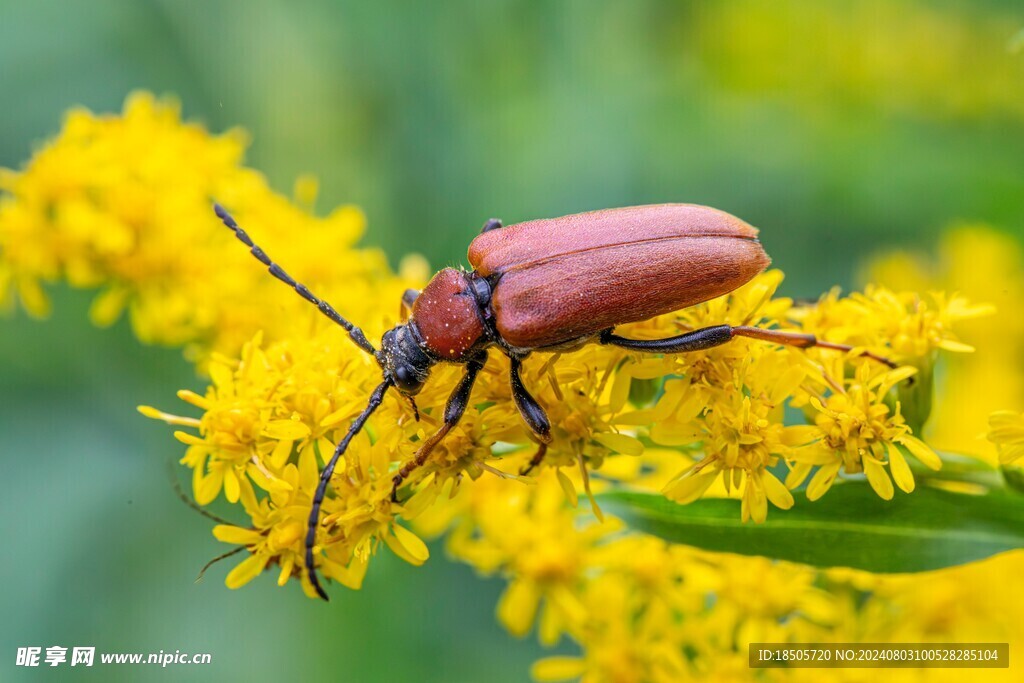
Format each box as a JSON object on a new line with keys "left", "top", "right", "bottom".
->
{"left": 214, "top": 204, "right": 895, "bottom": 600}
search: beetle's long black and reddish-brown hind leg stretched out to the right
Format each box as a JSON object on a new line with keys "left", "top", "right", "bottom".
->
{"left": 601, "top": 325, "right": 898, "bottom": 368}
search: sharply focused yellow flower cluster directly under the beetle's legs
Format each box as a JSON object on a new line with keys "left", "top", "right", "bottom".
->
{"left": 143, "top": 264, "right": 974, "bottom": 589}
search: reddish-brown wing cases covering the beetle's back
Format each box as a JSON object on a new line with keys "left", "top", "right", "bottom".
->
{"left": 469, "top": 204, "right": 769, "bottom": 348}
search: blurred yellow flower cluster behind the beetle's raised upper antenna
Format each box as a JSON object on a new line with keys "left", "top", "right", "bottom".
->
{"left": 0, "top": 93, "right": 397, "bottom": 360}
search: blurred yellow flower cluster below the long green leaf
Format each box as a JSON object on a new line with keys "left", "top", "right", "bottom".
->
{"left": 452, "top": 471, "right": 1024, "bottom": 683}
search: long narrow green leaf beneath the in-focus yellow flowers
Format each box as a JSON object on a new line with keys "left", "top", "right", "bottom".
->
{"left": 599, "top": 483, "right": 1024, "bottom": 572}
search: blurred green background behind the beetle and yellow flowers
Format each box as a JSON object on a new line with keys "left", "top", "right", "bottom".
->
{"left": 0, "top": 0, "right": 1024, "bottom": 682}
